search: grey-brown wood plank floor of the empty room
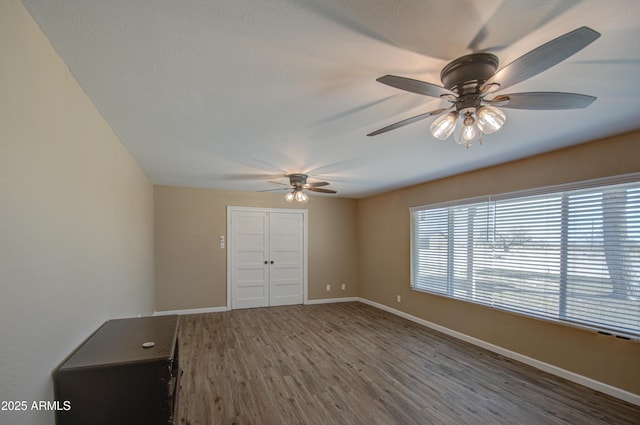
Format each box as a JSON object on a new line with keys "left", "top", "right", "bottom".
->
{"left": 178, "top": 303, "right": 640, "bottom": 425}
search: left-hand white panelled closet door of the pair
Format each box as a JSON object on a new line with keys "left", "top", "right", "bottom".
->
{"left": 231, "top": 211, "right": 269, "bottom": 308}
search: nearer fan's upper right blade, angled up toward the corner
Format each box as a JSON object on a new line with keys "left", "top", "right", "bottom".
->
{"left": 481, "top": 27, "right": 600, "bottom": 90}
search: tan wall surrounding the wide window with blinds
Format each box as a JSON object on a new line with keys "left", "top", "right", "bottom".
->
{"left": 357, "top": 132, "right": 640, "bottom": 394}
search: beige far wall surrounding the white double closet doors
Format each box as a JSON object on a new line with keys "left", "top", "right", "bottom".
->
{"left": 154, "top": 186, "right": 358, "bottom": 311}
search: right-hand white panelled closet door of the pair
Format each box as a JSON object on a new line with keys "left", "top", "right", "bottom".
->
{"left": 269, "top": 212, "right": 304, "bottom": 306}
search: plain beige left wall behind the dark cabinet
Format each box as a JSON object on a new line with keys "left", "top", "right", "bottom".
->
{"left": 0, "top": 0, "right": 154, "bottom": 425}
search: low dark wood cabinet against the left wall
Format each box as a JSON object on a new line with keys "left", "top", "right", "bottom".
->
{"left": 53, "top": 316, "right": 180, "bottom": 425}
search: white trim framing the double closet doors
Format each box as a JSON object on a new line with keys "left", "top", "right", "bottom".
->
{"left": 226, "top": 205, "right": 309, "bottom": 310}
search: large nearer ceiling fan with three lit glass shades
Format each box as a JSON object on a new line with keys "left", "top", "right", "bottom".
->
{"left": 367, "top": 27, "right": 600, "bottom": 148}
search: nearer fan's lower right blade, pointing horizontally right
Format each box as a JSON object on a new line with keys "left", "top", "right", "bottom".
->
{"left": 486, "top": 92, "right": 596, "bottom": 109}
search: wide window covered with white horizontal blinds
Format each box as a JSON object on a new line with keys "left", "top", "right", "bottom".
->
{"left": 411, "top": 174, "right": 640, "bottom": 338}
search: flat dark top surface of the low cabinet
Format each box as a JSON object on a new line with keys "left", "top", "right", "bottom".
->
{"left": 58, "top": 315, "right": 178, "bottom": 371}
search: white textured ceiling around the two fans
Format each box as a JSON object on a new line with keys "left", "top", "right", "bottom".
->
{"left": 24, "top": 0, "right": 640, "bottom": 198}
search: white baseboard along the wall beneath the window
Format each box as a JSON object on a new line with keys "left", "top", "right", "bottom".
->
{"left": 355, "top": 298, "right": 640, "bottom": 406}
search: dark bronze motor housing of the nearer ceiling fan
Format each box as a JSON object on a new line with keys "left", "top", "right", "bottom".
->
{"left": 440, "top": 53, "right": 498, "bottom": 96}
